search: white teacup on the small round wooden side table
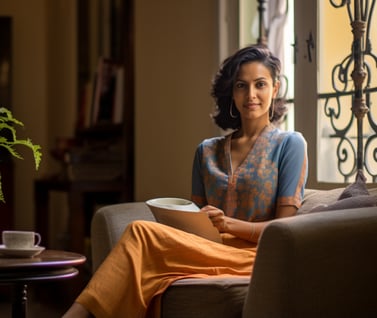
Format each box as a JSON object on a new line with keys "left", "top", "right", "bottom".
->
{"left": 2, "top": 231, "right": 42, "bottom": 249}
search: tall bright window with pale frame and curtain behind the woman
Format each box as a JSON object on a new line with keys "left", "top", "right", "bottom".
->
{"left": 239, "top": 0, "right": 377, "bottom": 187}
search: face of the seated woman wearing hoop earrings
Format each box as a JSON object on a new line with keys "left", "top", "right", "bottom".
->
{"left": 233, "top": 62, "right": 280, "bottom": 121}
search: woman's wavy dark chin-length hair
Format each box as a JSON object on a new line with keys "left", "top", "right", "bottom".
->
{"left": 211, "top": 44, "right": 287, "bottom": 130}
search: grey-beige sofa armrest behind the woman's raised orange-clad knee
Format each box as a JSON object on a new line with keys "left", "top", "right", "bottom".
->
{"left": 91, "top": 202, "right": 155, "bottom": 272}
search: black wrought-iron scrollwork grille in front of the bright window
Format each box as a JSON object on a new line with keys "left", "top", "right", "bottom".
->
{"left": 319, "top": 0, "right": 377, "bottom": 182}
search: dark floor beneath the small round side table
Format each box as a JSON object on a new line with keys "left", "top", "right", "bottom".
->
{"left": 0, "top": 275, "right": 89, "bottom": 318}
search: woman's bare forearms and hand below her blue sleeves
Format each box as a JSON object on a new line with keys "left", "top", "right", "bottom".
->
{"left": 201, "top": 205, "right": 297, "bottom": 242}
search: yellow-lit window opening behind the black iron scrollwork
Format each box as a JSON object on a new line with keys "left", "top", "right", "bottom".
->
{"left": 317, "top": 1, "right": 377, "bottom": 183}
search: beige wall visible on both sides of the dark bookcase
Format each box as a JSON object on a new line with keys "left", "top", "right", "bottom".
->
{"left": 0, "top": 0, "right": 218, "bottom": 229}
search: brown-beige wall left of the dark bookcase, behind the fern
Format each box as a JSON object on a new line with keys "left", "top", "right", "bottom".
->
{"left": 0, "top": 0, "right": 76, "bottom": 229}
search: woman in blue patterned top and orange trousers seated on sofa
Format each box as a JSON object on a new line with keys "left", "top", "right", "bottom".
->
{"left": 65, "top": 45, "right": 307, "bottom": 318}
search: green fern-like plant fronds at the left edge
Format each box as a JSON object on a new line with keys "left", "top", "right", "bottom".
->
{"left": 0, "top": 107, "right": 42, "bottom": 202}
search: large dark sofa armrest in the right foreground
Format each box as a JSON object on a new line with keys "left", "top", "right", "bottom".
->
{"left": 243, "top": 207, "right": 377, "bottom": 318}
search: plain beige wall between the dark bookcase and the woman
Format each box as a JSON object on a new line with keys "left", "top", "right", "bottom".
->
{"left": 135, "top": 0, "right": 218, "bottom": 200}
